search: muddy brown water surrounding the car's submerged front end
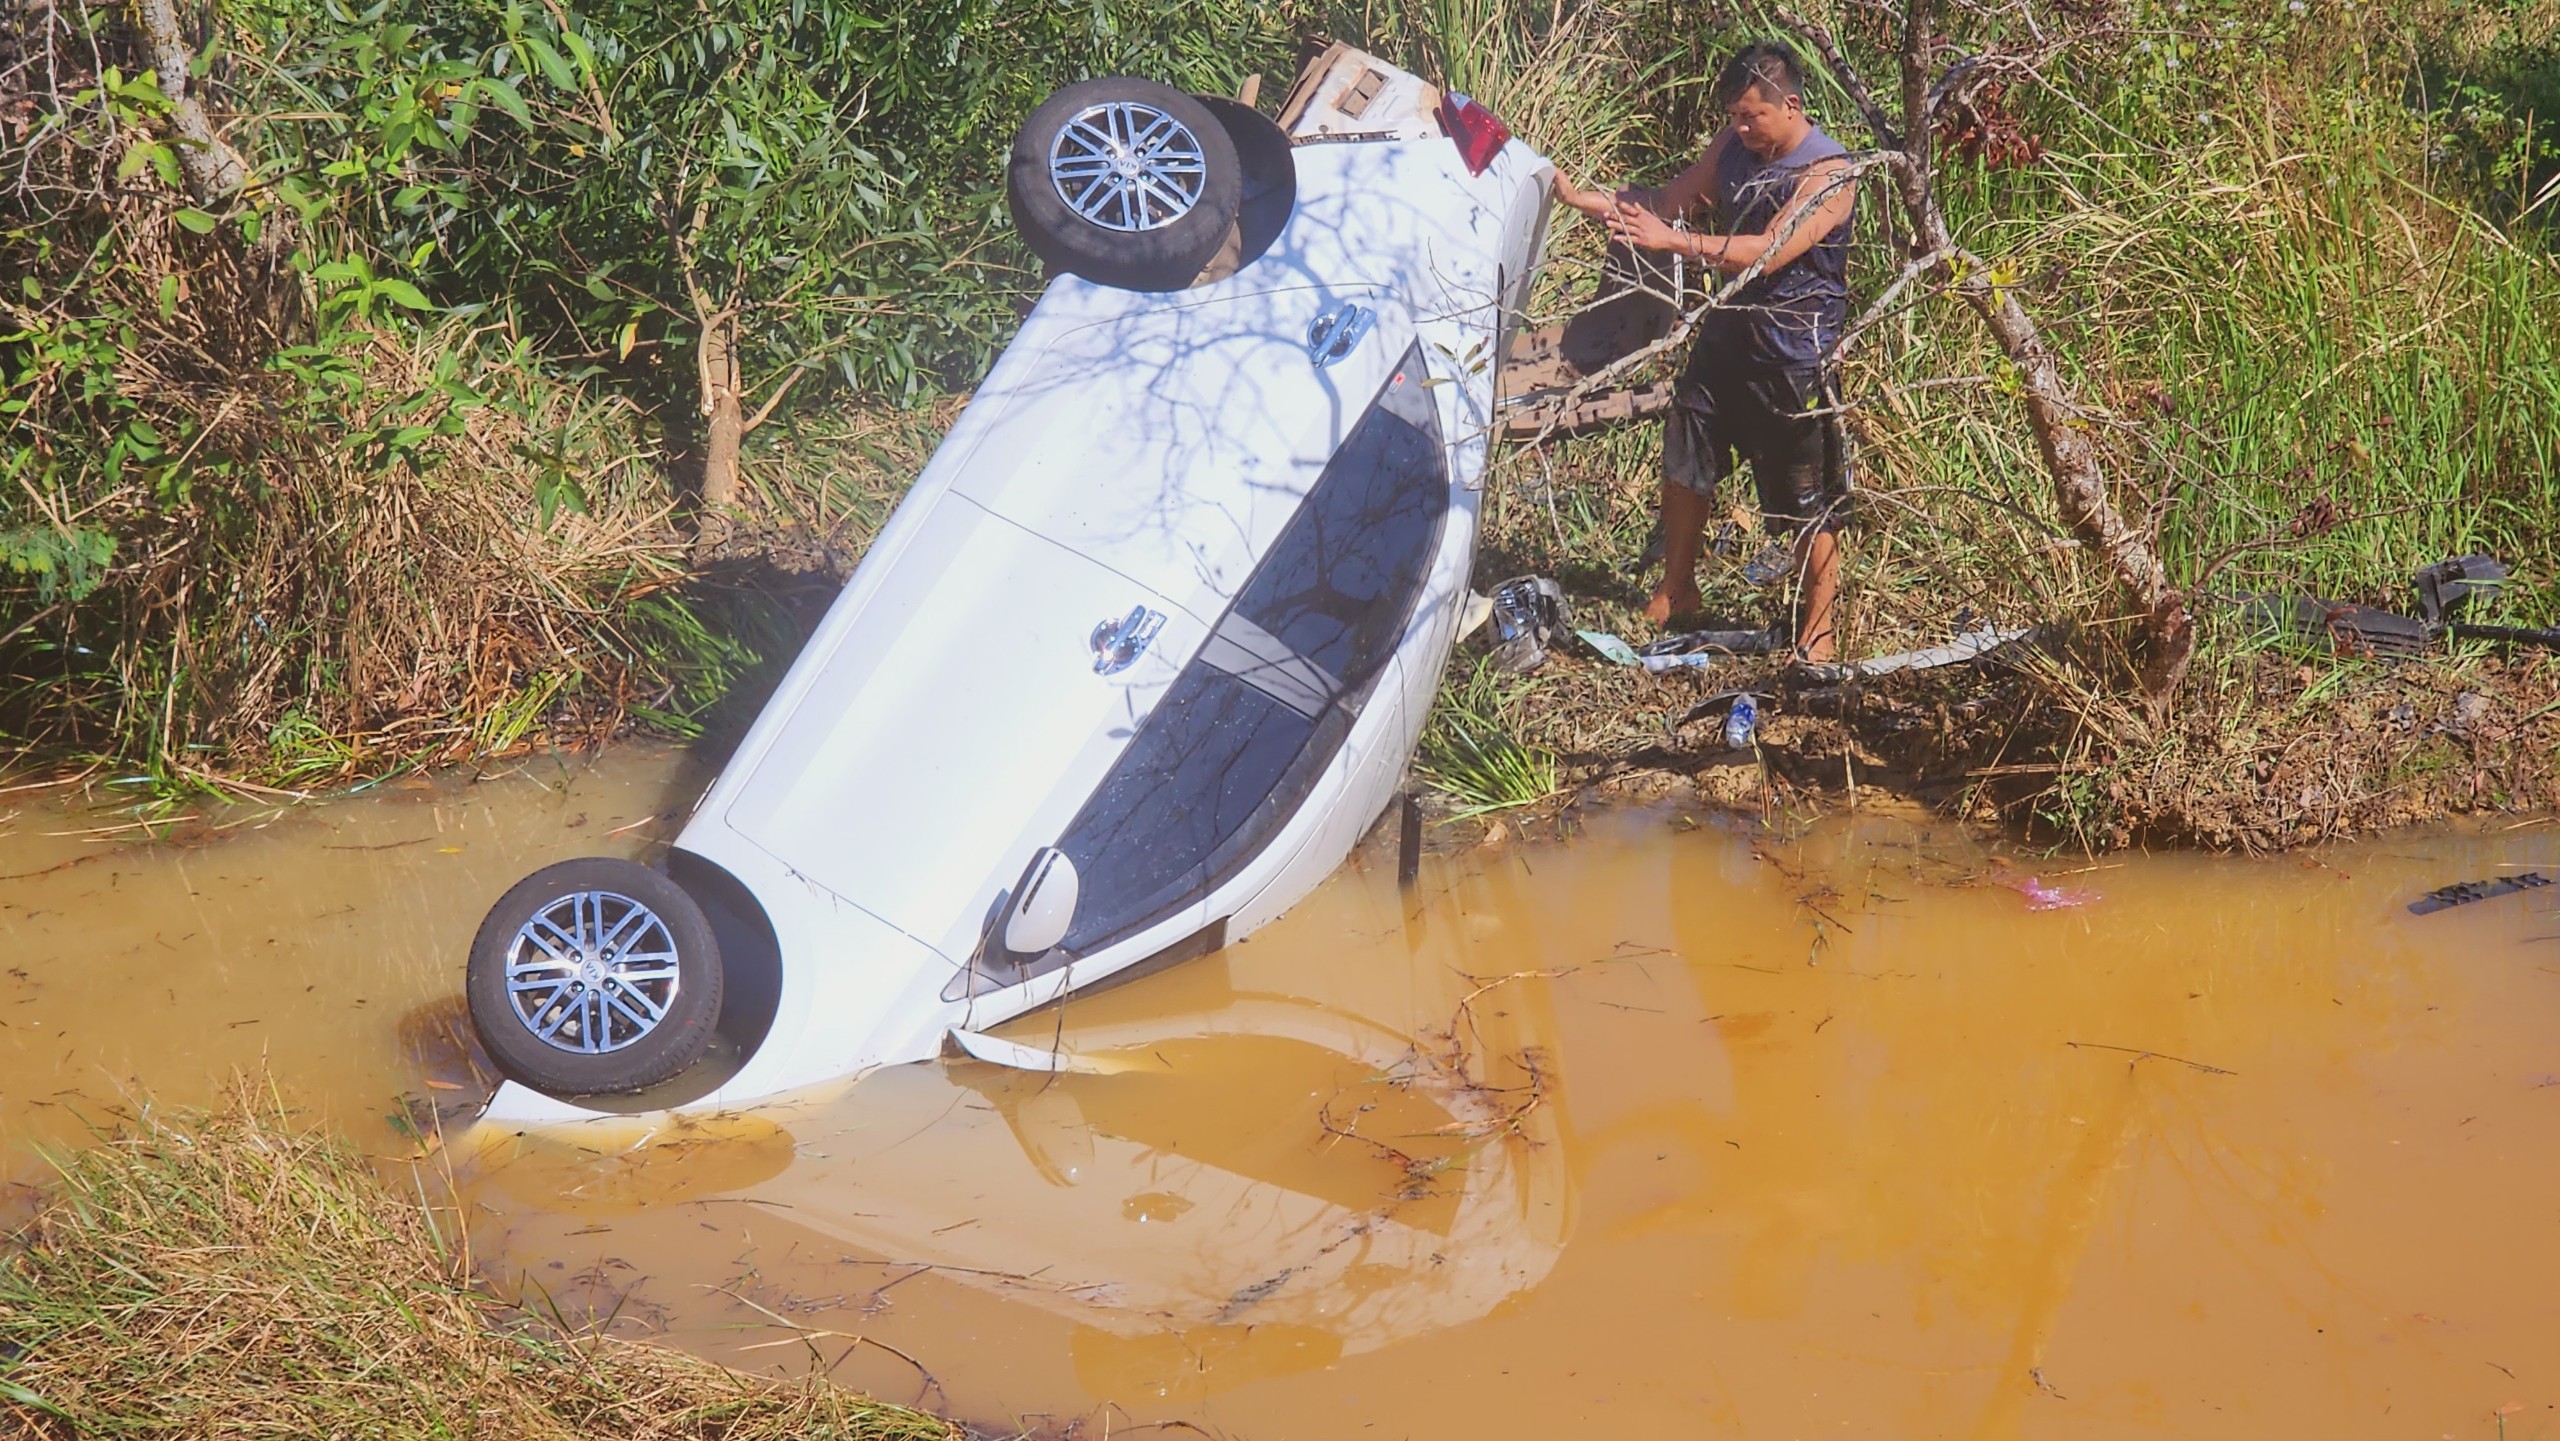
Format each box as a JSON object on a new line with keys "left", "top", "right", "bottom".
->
{"left": 0, "top": 750, "right": 2560, "bottom": 1441}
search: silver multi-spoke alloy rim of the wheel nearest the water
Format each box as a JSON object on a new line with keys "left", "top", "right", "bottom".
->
{"left": 507, "top": 891, "right": 678, "bottom": 1055}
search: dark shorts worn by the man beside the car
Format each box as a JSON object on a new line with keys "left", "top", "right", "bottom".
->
{"left": 1661, "top": 356, "right": 1848, "bottom": 535}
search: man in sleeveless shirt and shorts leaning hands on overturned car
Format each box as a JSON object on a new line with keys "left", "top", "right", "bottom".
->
{"left": 1556, "top": 41, "right": 1856, "bottom": 660}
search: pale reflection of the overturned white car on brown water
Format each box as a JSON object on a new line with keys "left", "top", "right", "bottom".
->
{"left": 466, "top": 865, "right": 1566, "bottom": 1397}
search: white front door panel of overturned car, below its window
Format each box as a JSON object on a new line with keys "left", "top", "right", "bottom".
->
{"left": 724, "top": 494, "right": 1203, "bottom": 962}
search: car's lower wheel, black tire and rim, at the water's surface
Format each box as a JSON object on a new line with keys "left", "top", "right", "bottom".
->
{"left": 463, "top": 857, "right": 722, "bottom": 1095}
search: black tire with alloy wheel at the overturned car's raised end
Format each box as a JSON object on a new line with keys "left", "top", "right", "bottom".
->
{"left": 1006, "top": 74, "right": 1244, "bottom": 289}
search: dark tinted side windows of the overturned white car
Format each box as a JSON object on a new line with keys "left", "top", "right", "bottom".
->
{"left": 1034, "top": 346, "right": 1449, "bottom": 955}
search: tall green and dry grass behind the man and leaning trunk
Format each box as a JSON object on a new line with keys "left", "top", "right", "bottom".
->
{"left": 1498, "top": 0, "right": 2560, "bottom": 650}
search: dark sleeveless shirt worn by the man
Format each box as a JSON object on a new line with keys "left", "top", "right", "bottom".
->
{"left": 1692, "top": 131, "right": 1856, "bottom": 371}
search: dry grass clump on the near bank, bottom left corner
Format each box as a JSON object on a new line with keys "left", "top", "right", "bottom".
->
{"left": 0, "top": 1085, "right": 960, "bottom": 1441}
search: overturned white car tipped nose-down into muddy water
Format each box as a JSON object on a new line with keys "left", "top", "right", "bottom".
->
{"left": 468, "top": 46, "right": 1549, "bottom": 1121}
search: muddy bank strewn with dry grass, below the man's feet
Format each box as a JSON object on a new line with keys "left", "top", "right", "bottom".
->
{"left": 1462, "top": 634, "right": 2560, "bottom": 852}
